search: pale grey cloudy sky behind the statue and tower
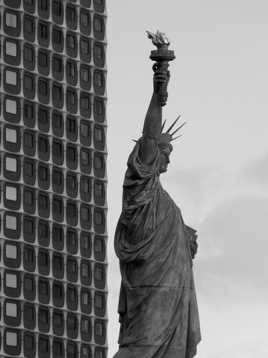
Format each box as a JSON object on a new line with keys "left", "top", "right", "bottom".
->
{"left": 107, "top": 0, "right": 268, "bottom": 358}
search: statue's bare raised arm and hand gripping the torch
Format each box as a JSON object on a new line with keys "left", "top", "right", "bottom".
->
{"left": 139, "top": 71, "right": 169, "bottom": 164}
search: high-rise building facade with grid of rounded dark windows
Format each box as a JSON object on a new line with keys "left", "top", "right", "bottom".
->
{"left": 0, "top": 0, "right": 107, "bottom": 358}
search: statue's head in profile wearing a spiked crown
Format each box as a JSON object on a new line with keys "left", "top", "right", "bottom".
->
{"left": 158, "top": 116, "right": 185, "bottom": 173}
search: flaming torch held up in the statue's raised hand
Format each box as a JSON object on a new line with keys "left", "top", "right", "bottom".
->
{"left": 146, "top": 31, "right": 175, "bottom": 106}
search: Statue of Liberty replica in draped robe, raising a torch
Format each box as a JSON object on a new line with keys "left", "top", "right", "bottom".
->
{"left": 114, "top": 31, "right": 201, "bottom": 358}
